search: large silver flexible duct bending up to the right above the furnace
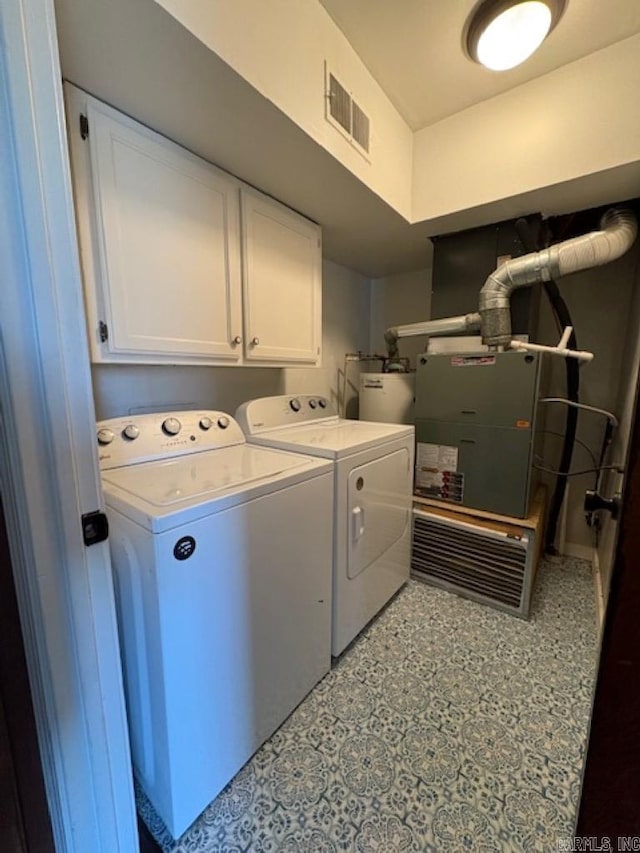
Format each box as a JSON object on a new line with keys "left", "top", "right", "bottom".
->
{"left": 479, "top": 209, "right": 638, "bottom": 346}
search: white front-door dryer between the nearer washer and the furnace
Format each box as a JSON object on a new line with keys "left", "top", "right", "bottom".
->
{"left": 236, "top": 395, "right": 414, "bottom": 655}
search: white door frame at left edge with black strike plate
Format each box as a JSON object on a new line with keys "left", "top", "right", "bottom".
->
{"left": 0, "top": 0, "right": 138, "bottom": 852}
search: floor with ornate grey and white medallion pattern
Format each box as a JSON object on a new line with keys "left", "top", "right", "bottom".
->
{"left": 137, "top": 560, "right": 597, "bottom": 853}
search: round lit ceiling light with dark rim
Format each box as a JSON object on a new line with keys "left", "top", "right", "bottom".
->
{"left": 465, "top": 0, "right": 566, "bottom": 71}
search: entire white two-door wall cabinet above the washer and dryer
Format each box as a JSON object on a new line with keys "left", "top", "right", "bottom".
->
{"left": 66, "top": 86, "right": 321, "bottom": 366}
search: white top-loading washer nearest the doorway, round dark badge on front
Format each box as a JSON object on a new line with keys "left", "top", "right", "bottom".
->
{"left": 98, "top": 411, "right": 333, "bottom": 838}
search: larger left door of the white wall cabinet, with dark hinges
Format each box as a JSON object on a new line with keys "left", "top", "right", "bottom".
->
{"left": 76, "top": 89, "right": 241, "bottom": 363}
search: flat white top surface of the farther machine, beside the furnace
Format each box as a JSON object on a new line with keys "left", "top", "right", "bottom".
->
{"left": 247, "top": 419, "right": 414, "bottom": 459}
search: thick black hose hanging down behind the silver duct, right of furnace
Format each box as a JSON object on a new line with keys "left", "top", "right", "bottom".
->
{"left": 516, "top": 219, "right": 580, "bottom": 554}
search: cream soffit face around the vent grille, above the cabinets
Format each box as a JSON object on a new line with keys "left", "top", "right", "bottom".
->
{"left": 156, "top": 0, "right": 412, "bottom": 219}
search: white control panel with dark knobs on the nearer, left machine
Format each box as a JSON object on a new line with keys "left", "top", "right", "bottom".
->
{"left": 96, "top": 410, "right": 245, "bottom": 470}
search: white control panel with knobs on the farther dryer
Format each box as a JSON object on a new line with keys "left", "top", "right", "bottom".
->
{"left": 236, "top": 394, "right": 338, "bottom": 435}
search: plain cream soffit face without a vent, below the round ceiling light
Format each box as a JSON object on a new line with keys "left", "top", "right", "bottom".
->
{"left": 412, "top": 35, "right": 640, "bottom": 227}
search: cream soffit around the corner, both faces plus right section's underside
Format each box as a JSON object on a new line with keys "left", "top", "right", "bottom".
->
{"left": 149, "top": 5, "right": 640, "bottom": 234}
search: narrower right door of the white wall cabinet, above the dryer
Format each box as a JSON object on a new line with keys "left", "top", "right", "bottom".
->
{"left": 241, "top": 188, "right": 322, "bottom": 365}
